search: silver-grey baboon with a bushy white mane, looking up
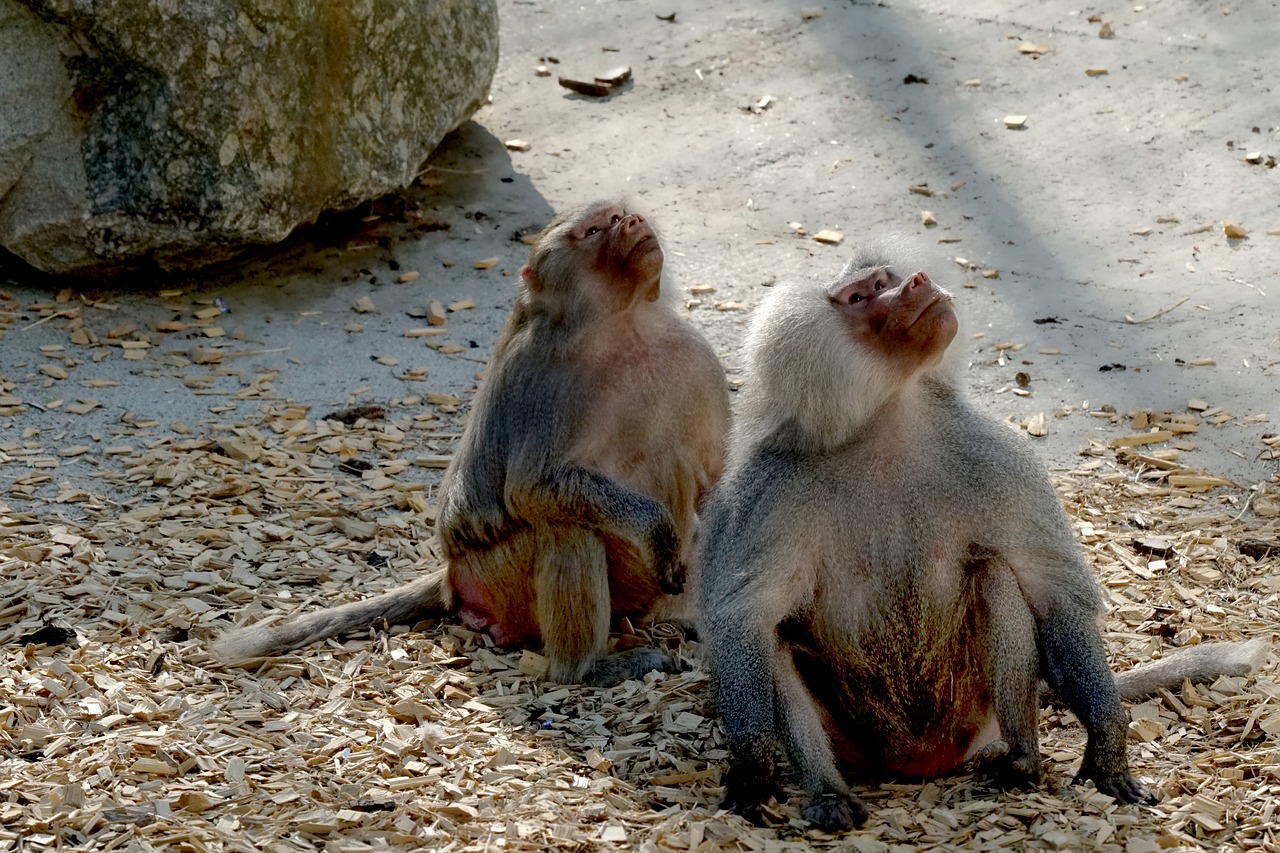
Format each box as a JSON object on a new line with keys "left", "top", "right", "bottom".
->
{"left": 696, "top": 236, "right": 1267, "bottom": 830}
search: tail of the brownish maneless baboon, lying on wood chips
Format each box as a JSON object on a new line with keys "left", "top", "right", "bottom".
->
{"left": 216, "top": 567, "right": 454, "bottom": 666}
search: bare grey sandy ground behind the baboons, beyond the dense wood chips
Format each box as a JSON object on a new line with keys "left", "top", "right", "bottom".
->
{"left": 0, "top": 0, "right": 1280, "bottom": 850}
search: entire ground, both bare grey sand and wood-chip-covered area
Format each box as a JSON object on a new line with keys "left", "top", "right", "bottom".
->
{"left": 0, "top": 0, "right": 1280, "bottom": 850}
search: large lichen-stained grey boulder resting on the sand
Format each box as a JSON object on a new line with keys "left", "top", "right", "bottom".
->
{"left": 0, "top": 0, "right": 498, "bottom": 273}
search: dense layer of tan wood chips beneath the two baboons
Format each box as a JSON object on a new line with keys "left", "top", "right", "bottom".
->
{"left": 0, "top": 389, "right": 1280, "bottom": 853}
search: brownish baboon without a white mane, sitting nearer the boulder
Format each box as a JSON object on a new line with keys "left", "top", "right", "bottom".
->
{"left": 214, "top": 202, "right": 728, "bottom": 684}
